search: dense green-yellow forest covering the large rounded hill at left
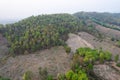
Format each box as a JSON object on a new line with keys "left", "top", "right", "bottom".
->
{"left": 0, "top": 14, "right": 83, "bottom": 54}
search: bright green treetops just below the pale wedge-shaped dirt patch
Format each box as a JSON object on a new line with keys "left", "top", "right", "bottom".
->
{"left": 76, "top": 48, "right": 112, "bottom": 63}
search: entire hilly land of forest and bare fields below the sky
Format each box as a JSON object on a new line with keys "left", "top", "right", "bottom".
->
{"left": 0, "top": 12, "right": 120, "bottom": 80}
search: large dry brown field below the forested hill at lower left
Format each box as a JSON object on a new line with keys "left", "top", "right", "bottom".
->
{"left": 0, "top": 46, "right": 70, "bottom": 80}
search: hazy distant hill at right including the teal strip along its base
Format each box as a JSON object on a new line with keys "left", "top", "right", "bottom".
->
{"left": 74, "top": 12, "right": 120, "bottom": 31}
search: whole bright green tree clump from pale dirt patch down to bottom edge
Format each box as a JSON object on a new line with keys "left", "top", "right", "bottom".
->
{"left": 58, "top": 48, "right": 111, "bottom": 80}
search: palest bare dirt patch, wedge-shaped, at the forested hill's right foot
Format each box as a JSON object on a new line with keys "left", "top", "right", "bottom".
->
{"left": 66, "top": 33, "right": 94, "bottom": 52}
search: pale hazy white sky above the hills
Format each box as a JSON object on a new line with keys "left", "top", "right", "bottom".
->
{"left": 0, "top": 0, "right": 120, "bottom": 19}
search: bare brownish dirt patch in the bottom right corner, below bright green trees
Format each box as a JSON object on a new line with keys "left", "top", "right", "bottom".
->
{"left": 93, "top": 64, "right": 120, "bottom": 80}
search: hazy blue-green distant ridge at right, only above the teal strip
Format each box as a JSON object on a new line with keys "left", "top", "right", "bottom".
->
{"left": 74, "top": 12, "right": 120, "bottom": 26}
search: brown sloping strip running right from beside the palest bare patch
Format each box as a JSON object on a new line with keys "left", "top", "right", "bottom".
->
{"left": 79, "top": 32, "right": 120, "bottom": 56}
